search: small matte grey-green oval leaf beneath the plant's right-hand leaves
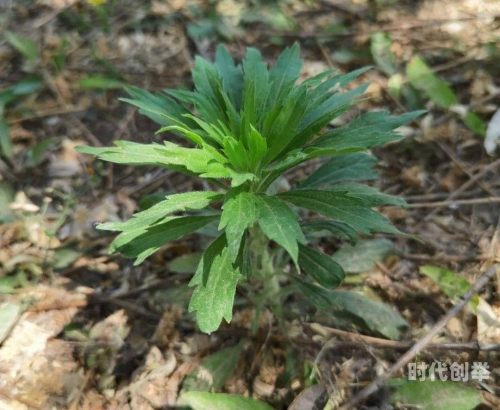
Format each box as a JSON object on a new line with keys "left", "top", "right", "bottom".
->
{"left": 332, "top": 238, "right": 394, "bottom": 273}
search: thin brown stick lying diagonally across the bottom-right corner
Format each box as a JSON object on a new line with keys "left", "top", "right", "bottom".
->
{"left": 339, "top": 265, "right": 500, "bottom": 410}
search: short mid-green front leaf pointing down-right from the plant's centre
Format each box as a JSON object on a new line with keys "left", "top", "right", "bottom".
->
{"left": 256, "top": 195, "right": 306, "bottom": 264}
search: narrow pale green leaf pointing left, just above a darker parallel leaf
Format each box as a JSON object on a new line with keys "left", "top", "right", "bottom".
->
{"left": 97, "top": 191, "right": 223, "bottom": 231}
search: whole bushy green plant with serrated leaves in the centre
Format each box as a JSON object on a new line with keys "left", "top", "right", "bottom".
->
{"left": 79, "top": 45, "right": 421, "bottom": 332}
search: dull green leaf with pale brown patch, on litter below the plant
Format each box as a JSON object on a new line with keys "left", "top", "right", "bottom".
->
{"left": 181, "top": 340, "right": 245, "bottom": 395}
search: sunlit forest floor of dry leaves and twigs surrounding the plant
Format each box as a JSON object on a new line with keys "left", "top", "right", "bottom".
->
{"left": 0, "top": 0, "right": 500, "bottom": 410}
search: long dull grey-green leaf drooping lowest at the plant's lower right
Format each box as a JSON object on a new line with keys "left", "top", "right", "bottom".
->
{"left": 292, "top": 277, "right": 409, "bottom": 339}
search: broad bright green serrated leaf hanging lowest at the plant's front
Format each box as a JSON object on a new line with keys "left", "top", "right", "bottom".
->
{"left": 189, "top": 235, "right": 242, "bottom": 333}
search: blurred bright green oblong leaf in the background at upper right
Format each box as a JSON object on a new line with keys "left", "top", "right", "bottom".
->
{"left": 406, "top": 56, "right": 457, "bottom": 108}
